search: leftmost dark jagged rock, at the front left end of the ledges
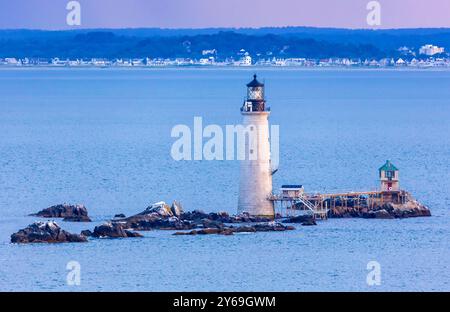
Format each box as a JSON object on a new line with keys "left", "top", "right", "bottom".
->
{"left": 11, "top": 221, "right": 87, "bottom": 244}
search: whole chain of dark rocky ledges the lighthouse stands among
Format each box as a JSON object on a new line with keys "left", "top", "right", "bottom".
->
{"left": 11, "top": 185, "right": 431, "bottom": 243}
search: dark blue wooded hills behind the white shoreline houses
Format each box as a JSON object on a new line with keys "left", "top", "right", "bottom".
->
{"left": 0, "top": 27, "right": 450, "bottom": 60}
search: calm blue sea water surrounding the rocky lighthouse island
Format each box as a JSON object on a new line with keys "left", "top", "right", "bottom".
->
{"left": 0, "top": 69, "right": 450, "bottom": 291}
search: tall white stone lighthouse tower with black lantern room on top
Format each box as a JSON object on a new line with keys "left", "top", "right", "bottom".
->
{"left": 238, "top": 75, "right": 275, "bottom": 217}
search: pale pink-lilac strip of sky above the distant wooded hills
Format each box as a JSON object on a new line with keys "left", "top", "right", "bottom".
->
{"left": 0, "top": 0, "right": 450, "bottom": 29}
